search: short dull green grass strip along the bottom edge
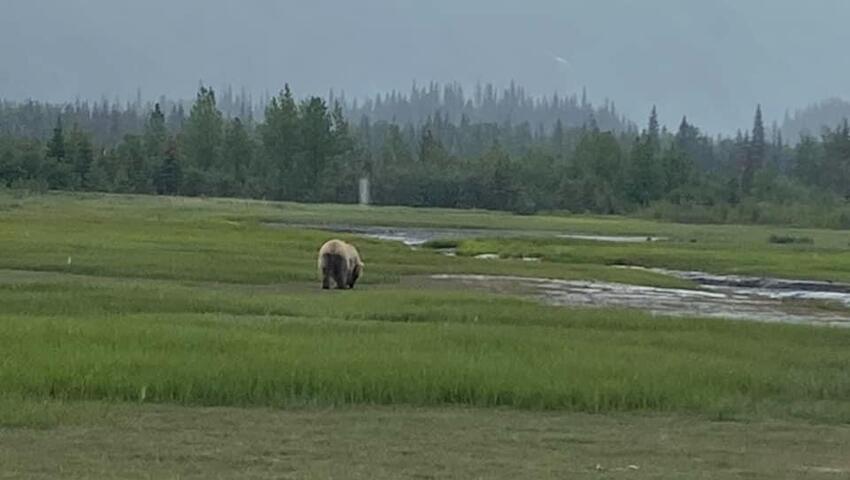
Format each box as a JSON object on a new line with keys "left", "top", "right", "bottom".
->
{"left": 6, "top": 401, "right": 850, "bottom": 480}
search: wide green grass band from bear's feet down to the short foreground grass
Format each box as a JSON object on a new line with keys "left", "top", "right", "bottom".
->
{"left": 0, "top": 280, "right": 850, "bottom": 421}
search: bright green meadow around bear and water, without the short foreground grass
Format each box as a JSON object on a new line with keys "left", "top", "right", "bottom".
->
{"left": 0, "top": 193, "right": 850, "bottom": 478}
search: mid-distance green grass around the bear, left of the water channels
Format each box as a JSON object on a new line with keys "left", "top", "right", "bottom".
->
{"left": 0, "top": 194, "right": 690, "bottom": 287}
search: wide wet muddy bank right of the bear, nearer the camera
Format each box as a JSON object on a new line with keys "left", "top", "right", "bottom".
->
{"left": 431, "top": 275, "right": 850, "bottom": 327}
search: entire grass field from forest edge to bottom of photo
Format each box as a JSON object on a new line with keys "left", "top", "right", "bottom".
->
{"left": 0, "top": 190, "right": 850, "bottom": 478}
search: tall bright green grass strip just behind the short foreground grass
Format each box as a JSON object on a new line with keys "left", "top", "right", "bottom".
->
{"left": 0, "top": 314, "right": 850, "bottom": 421}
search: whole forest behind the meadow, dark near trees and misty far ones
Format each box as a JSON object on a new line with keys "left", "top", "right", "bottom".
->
{"left": 0, "top": 84, "right": 850, "bottom": 228}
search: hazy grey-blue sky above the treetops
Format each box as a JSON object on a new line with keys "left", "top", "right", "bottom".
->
{"left": 0, "top": 0, "right": 850, "bottom": 132}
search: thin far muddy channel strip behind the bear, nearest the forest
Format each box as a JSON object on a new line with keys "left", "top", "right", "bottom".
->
{"left": 266, "top": 223, "right": 666, "bottom": 246}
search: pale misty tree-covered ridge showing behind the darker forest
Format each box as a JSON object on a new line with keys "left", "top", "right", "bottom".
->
{"left": 0, "top": 82, "right": 850, "bottom": 144}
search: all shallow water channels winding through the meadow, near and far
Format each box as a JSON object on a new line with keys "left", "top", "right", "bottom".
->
{"left": 273, "top": 224, "right": 850, "bottom": 326}
